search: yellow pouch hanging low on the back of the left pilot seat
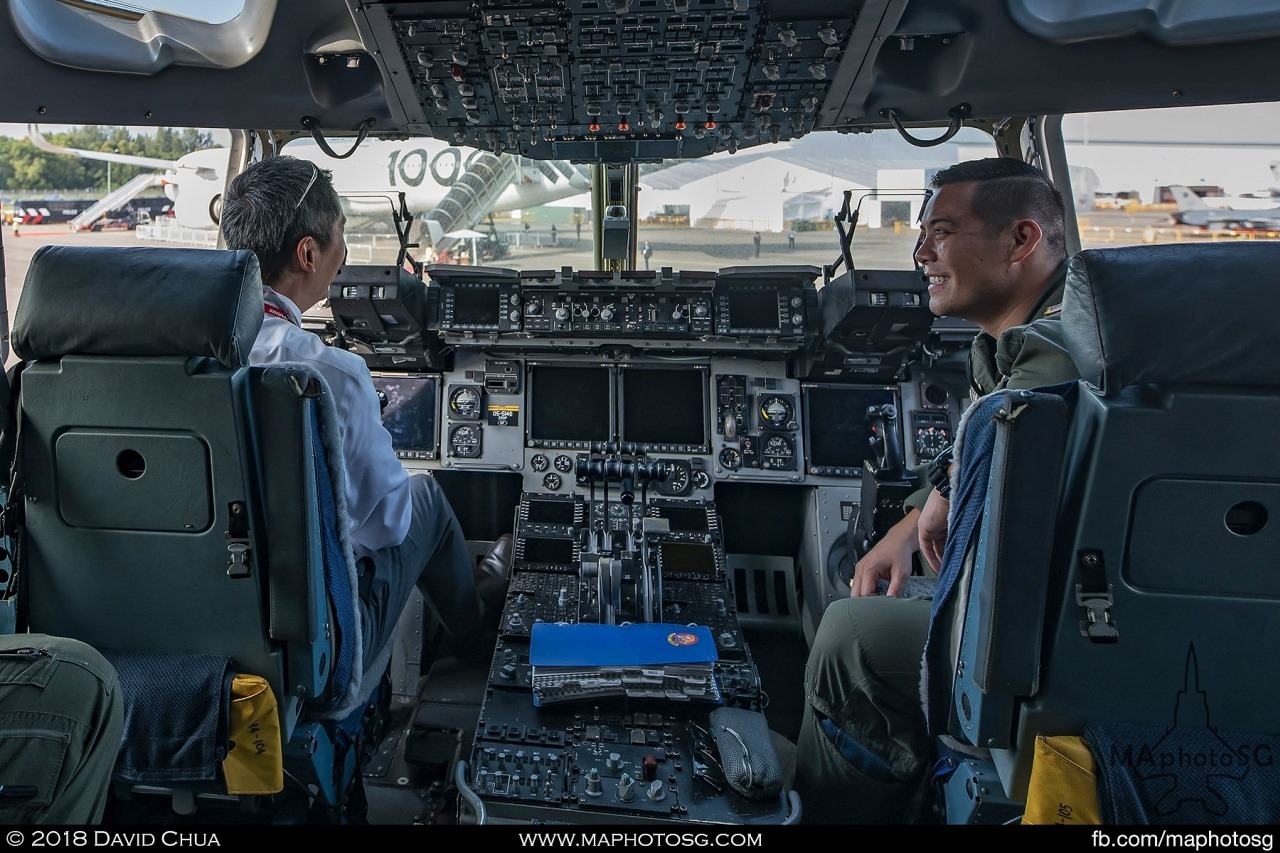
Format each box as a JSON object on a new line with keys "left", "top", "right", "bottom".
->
{"left": 223, "top": 675, "right": 284, "bottom": 794}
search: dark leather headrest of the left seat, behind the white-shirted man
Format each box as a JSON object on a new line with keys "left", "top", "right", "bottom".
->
{"left": 13, "top": 246, "right": 262, "bottom": 368}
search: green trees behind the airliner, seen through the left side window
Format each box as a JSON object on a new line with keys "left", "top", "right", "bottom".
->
{"left": 0, "top": 124, "right": 214, "bottom": 192}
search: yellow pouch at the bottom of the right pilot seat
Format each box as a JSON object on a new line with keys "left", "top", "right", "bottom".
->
{"left": 1023, "top": 735, "right": 1102, "bottom": 826}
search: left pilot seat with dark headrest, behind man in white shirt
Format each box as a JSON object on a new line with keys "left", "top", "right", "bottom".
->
{"left": 5, "top": 246, "right": 385, "bottom": 822}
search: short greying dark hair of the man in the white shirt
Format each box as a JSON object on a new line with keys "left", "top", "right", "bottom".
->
{"left": 221, "top": 155, "right": 342, "bottom": 282}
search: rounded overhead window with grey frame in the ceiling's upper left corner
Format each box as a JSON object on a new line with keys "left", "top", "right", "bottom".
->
{"left": 9, "top": 0, "right": 276, "bottom": 76}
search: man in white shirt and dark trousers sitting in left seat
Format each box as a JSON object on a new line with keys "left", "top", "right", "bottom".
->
{"left": 221, "top": 156, "right": 512, "bottom": 666}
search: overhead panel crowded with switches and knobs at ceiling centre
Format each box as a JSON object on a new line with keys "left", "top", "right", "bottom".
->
{"left": 364, "top": 0, "right": 855, "bottom": 161}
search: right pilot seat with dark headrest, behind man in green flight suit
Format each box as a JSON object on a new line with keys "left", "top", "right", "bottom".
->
{"left": 925, "top": 242, "right": 1280, "bottom": 824}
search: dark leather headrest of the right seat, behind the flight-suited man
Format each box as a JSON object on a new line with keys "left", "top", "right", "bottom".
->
{"left": 1062, "top": 241, "right": 1280, "bottom": 396}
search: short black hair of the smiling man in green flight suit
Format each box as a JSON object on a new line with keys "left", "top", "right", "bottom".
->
{"left": 931, "top": 158, "right": 1066, "bottom": 257}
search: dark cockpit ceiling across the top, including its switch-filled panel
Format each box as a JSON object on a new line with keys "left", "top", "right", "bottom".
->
{"left": 0, "top": 0, "right": 1280, "bottom": 161}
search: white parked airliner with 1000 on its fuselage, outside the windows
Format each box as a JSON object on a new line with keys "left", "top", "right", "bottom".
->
{"left": 27, "top": 124, "right": 590, "bottom": 231}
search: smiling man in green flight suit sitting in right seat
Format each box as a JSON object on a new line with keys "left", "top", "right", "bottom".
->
{"left": 795, "top": 158, "right": 1078, "bottom": 824}
